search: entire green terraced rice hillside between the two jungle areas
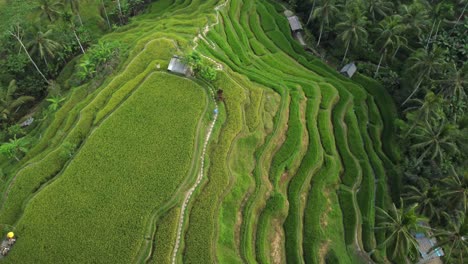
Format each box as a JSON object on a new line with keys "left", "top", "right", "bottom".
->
{"left": 0, "top": 0, "right": 395, "bottom": 263}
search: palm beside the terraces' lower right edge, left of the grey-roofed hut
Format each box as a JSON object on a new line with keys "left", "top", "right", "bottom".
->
{"left": 377, "top": 201, "right": 426, "bottom": 263}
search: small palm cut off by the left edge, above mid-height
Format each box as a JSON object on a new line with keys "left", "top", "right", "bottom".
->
{"left": 0, "top": 80, "right": 35, "bottom": 126}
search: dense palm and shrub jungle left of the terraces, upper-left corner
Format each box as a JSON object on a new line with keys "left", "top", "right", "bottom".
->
{"left": 0, "top": 0, "right": 150, "bottom": 162}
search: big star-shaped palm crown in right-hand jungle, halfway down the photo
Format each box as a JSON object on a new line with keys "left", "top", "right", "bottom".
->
{"left": 410, "top": 119, "right": 459, "bottom": 164}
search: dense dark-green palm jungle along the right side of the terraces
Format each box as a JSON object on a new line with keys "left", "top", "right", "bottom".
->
{"left": 288, "top": 0, "right": 468, "bottom": 263}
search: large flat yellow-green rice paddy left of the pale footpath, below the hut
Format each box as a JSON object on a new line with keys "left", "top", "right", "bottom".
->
{"left": 3, "top": 73, "right": 206, "bottom": 263}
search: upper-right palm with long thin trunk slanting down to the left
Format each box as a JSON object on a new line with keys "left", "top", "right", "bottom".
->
{"left": 402, "top": 46, "right": 446, "bottom": 105}
